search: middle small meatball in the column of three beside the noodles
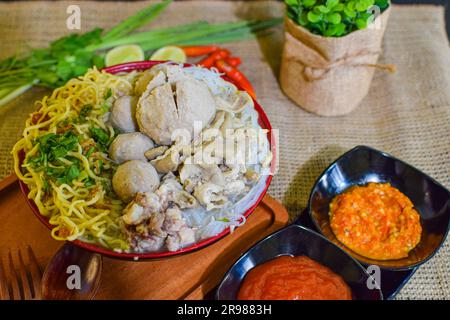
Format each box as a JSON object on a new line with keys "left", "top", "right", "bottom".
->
{"left": 109, "top": 132, "right": 154, "bottom": 164}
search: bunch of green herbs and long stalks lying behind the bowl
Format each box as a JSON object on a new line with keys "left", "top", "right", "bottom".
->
{"left": 0, "top": 0, "right": 282, "bottom": 109}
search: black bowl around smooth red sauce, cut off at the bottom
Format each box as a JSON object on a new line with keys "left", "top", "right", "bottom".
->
{"left": 216, "top": 224, "right": 383, "bottom": 300}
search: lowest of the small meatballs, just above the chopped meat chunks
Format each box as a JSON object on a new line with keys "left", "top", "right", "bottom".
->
{"left": 112, "top": 160, "right": 159, "bottom": 202}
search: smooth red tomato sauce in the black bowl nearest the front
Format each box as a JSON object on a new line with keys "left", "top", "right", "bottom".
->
{"left": 237, "top": 256, "right": 352, "bottom": 300}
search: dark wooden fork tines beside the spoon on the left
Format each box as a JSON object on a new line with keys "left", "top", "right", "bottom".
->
{"left": 0, "top": 246, "right": 42, "bottom": 300}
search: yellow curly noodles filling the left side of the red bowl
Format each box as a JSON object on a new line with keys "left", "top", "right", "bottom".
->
{"left": 12, "top": 68, "right": 133, "bottom": 251}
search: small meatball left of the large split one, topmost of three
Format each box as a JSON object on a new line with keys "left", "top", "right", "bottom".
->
{"left": 110, "top": 96, "right": 138, "bottom": 132}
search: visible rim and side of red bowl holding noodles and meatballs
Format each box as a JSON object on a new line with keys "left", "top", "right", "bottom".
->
{"left": 19, "top": 61, "right": 276, "bottom": 260}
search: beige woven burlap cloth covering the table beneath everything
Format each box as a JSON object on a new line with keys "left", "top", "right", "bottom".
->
{"left": 0, "top": 0, "right": 450, "bottom": 299}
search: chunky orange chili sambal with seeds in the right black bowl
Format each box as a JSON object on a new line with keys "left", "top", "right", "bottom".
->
{"left": 330, "top": 182, "right": 422, "bottom": 260}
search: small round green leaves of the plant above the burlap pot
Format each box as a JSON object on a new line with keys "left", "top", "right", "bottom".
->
{"left": 285, "top": 0, "right": 389, "bottom": 37}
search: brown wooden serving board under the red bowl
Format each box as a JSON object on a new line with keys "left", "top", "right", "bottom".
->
{"left": 0, "top": 176, "right": 288, "bottom": 299}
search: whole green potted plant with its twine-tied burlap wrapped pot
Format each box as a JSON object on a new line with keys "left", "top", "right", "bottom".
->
{"left": 280, "top": 0, "right": 394, "bottom": 116}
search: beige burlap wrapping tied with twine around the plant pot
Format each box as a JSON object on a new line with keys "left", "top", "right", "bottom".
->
{"left": 280, "top": 7, "right": 391, "bottom": 116}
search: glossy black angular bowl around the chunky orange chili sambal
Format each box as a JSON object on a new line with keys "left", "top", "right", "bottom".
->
{"left": 308, "top": 146, "right": 450, "bottom": 270}
